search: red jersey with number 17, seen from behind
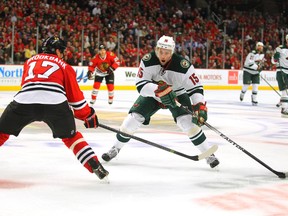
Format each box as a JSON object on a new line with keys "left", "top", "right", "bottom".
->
{"left": 14, "top": 53, "right": 90, "bottom": 120}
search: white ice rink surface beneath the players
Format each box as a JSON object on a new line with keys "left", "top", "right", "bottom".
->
{"left": 0, "top": 90, "right": 288, "bottom": 216}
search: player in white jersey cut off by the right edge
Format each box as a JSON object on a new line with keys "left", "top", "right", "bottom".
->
{"left": 272, "top": 34, "right": 288, "bottom": 117}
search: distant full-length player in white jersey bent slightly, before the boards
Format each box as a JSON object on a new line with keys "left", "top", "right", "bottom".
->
{"left": 240, "top": 42, "right": 265, "bottom": 106}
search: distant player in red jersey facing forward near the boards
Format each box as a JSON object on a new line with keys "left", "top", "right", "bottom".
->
{"left": 87, "top": 45, "right": 120, "bottom": 105}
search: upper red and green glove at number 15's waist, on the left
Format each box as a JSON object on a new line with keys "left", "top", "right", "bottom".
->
{"left": 155, "top": 81, "right": 177, "bottom": 108}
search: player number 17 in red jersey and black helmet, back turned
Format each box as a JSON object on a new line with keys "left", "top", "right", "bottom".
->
{"left": 0, "top": 36, "right": 109, "bottom": 179}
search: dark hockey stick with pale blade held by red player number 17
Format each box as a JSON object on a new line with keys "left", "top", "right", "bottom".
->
{"left": 98, "top": 123, "right": 218, "bottom": 161}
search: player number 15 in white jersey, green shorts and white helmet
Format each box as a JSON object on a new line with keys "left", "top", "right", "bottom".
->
{"left": 102, "top": 35, "right": 219, "bottom": 168}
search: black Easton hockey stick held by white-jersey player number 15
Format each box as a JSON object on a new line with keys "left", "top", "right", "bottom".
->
{"left": 176, "top": 101, "right": 288, "bottom": 179}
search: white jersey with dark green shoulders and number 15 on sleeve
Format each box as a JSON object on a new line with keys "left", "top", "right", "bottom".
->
{"left": 136, "top": 51, "right": 205, "bottom": 104}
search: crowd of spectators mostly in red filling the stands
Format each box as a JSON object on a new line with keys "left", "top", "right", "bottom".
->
{"left": 0, "top": 0, "right": 288, "bottom": 70}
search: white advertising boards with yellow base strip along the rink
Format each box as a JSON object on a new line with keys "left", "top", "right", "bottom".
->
{"left": 0, "top": 65, "right": 278, "bottom": 91}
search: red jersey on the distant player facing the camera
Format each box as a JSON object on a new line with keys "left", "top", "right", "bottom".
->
{"left": 88, "top": 51, "right": 120, "bottom": 76}
